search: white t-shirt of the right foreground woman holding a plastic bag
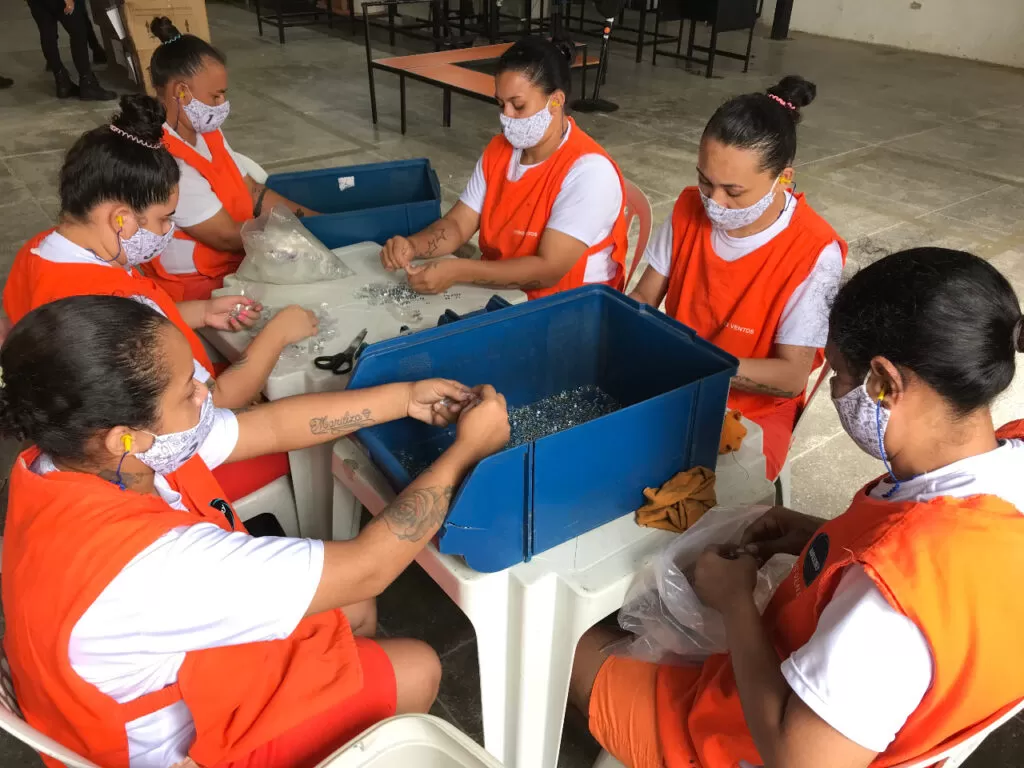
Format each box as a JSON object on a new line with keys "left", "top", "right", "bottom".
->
{"left": 782, "top": 440, "right": 1024, "bottom": 752}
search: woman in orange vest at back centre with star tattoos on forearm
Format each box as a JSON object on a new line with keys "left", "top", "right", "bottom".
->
{"left": 381, "top": 37, "right": 627, "bottom": 299}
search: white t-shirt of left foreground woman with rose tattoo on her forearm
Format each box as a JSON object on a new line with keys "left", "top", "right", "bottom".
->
{"left": 32, "top": 409, "right": 324, "bottom": 768}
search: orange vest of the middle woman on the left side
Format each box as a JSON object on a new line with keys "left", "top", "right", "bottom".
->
{"left": 3, "top": 229, "right": 213, "bottom": 376}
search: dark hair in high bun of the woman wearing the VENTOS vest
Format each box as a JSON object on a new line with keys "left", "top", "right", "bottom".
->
{"left": 703, "top": 75, "right": 817, "bottom": 174}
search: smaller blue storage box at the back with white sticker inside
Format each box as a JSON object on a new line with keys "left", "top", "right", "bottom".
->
{"left": 266, "top": 158, "right": 441, "bottom": 248}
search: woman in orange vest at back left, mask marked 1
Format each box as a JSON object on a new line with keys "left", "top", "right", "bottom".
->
{"left": 144, "top": 16, "right": 313, "bottom": 301}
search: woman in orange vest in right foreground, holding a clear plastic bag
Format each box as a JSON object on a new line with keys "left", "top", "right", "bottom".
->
{"left": 570, "top": 248, "right": 1024, "bottom": 768}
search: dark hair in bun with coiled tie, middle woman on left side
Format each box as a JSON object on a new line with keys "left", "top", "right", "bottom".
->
{"left": 59, "top": 94, "right": 180, "bottom": 218}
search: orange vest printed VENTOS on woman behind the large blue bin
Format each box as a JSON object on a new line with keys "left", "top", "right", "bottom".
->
{"left": 665, "top": 187, "right": 847, "bottom": 479}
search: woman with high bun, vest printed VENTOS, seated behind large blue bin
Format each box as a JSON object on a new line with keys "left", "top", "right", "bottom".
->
{"left": 631, "top": 77, "right": 847, "bottom": 480}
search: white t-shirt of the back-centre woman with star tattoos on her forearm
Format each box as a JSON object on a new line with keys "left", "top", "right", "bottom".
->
{"left": 460, "top": 125, "right": 623, "bottom": 283}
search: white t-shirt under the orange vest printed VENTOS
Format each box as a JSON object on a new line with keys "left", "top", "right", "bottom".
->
{"left": 644, "top": 190, "right": 843, "bottom": 347}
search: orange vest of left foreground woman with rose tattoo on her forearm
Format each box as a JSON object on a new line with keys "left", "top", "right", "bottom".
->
{"left": 0, "top": 447, "right": 362, "bottom": 768}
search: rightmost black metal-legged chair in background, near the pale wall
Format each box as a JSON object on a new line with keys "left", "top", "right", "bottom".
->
{"left": 651, "top": 0, "right": 758, "bottom": 78}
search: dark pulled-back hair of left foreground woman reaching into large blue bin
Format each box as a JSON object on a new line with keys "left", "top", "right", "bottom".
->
{"left": 0, "top": 296, "right": 170, "bottom": 461}
